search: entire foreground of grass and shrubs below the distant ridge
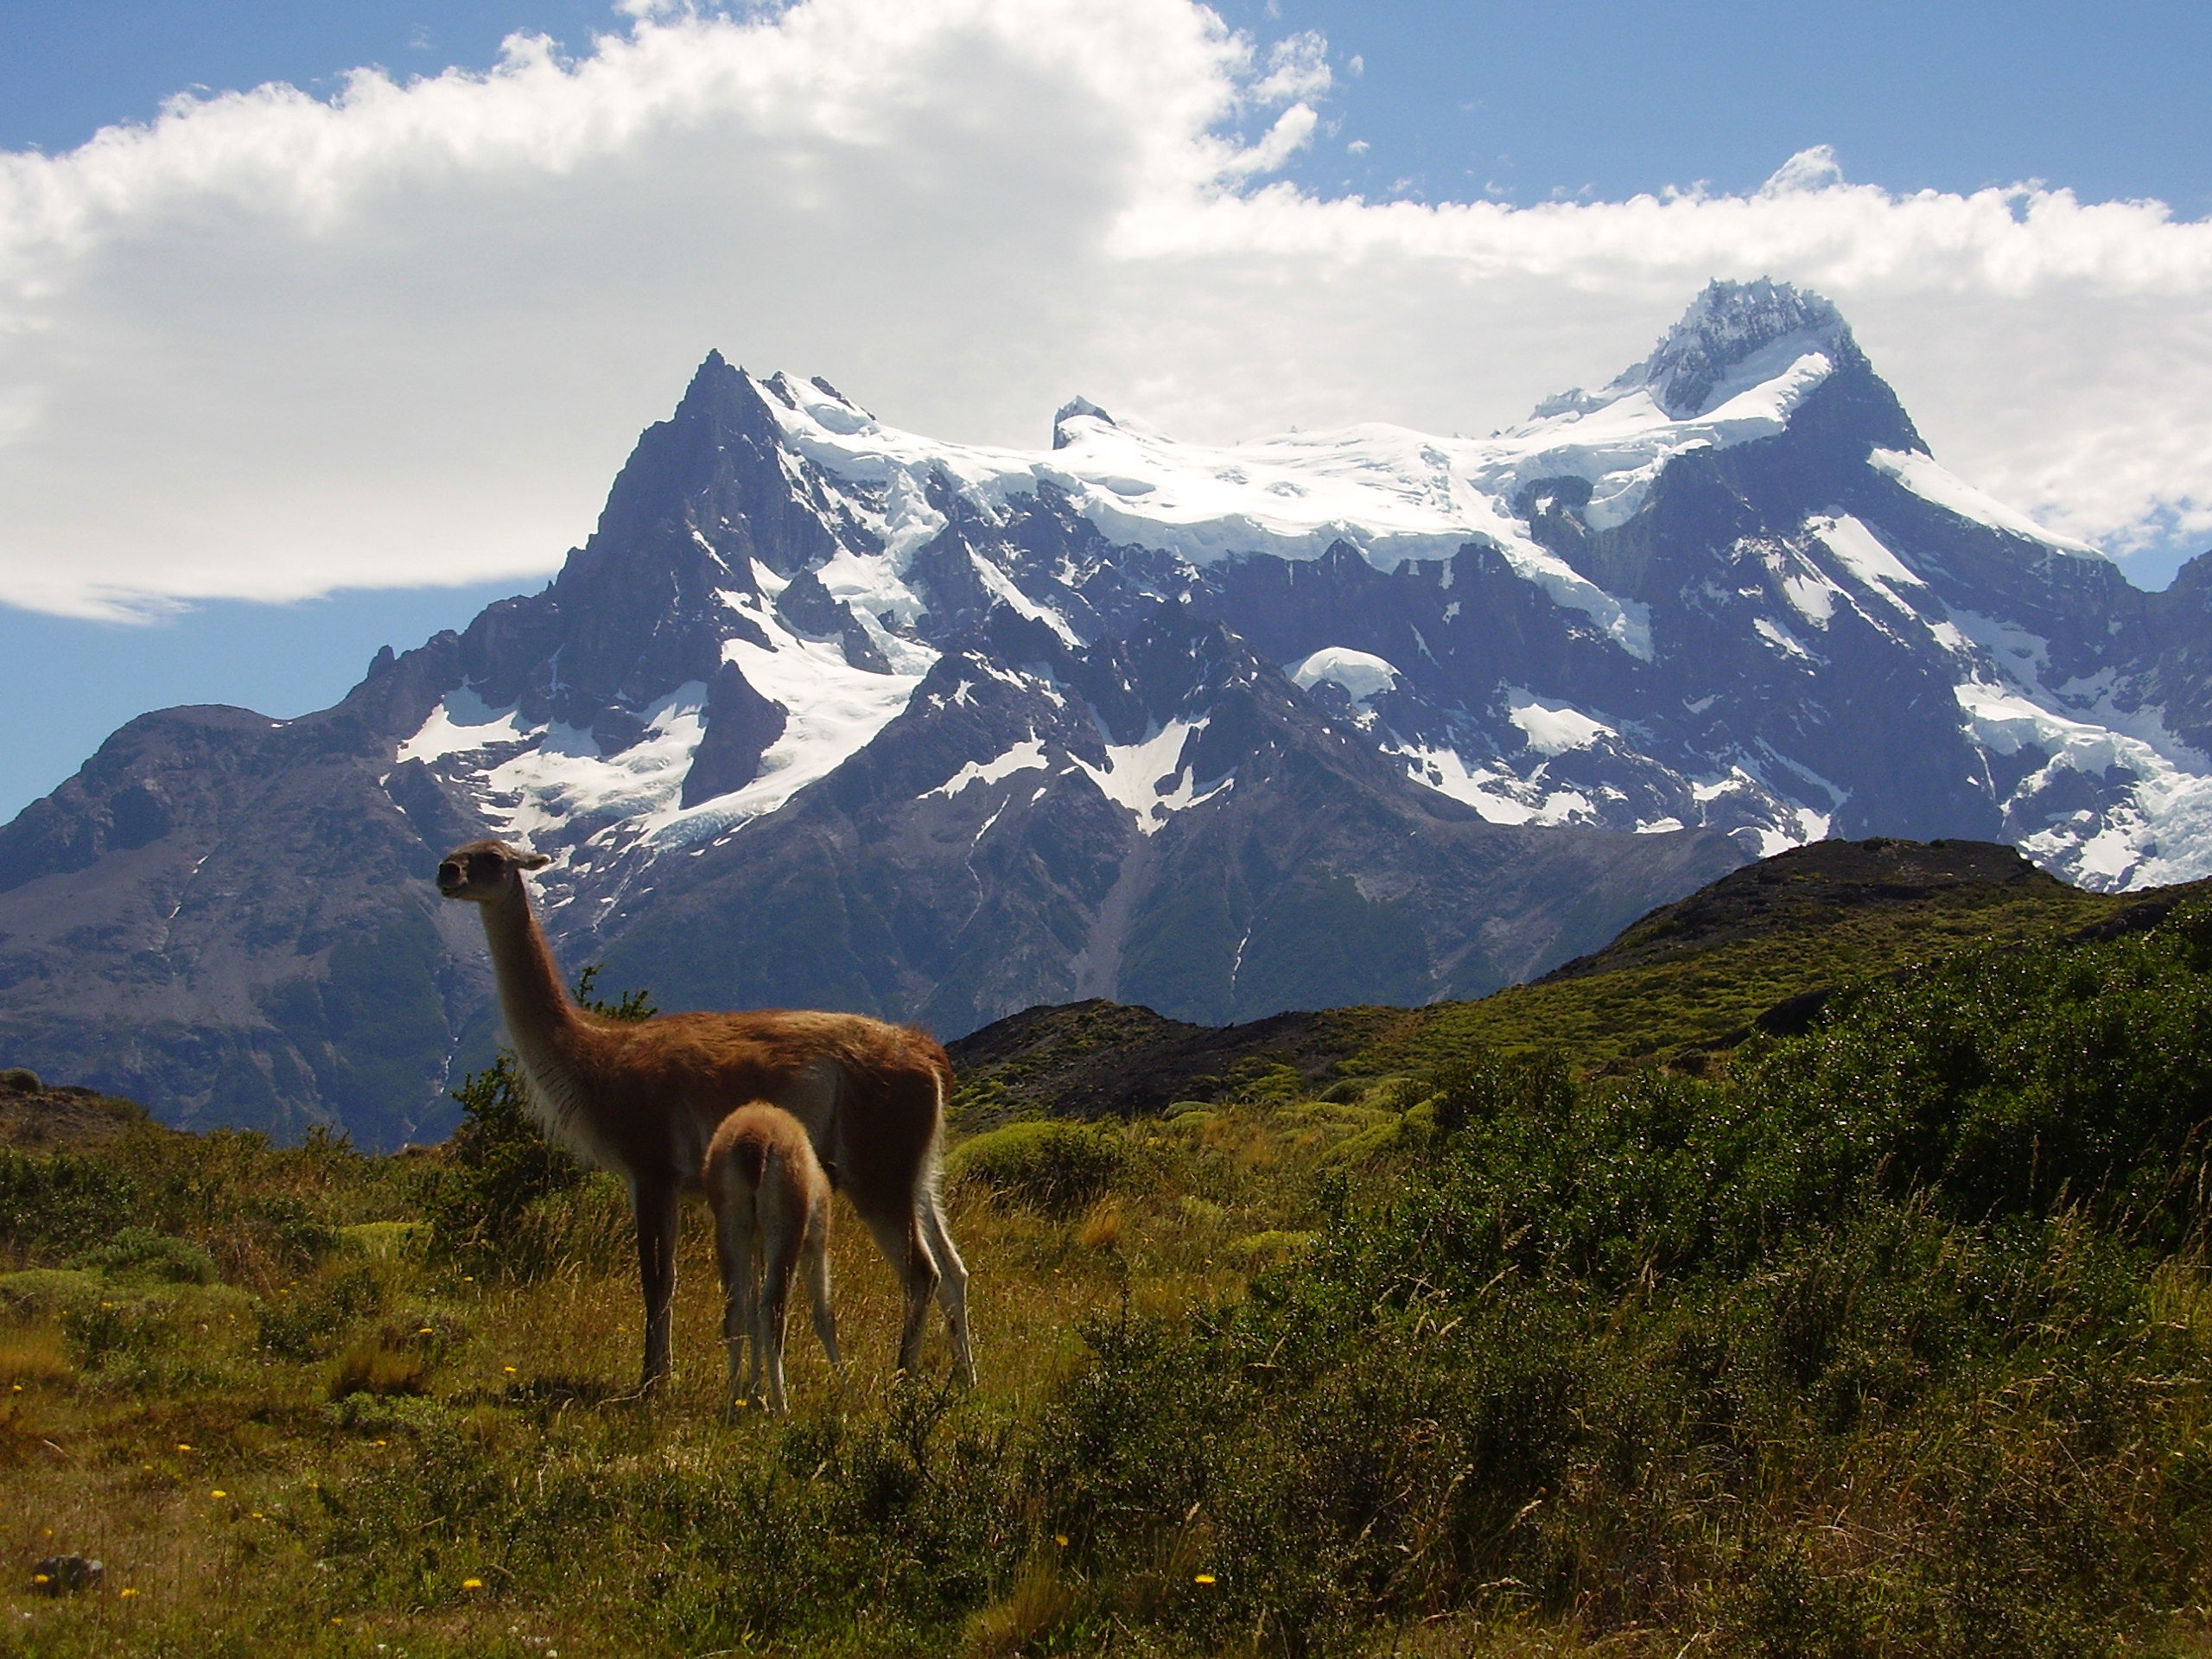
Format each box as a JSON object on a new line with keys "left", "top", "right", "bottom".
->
{"left": 0, "top": 898, "right": 2212, "bottom": 1659}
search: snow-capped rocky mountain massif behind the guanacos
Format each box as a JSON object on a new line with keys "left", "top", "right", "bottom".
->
{"left": 0, "top": 283, "right": 2212, "bottom": 1146}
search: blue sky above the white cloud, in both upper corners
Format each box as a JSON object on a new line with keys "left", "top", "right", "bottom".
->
{"left": 17, "top": 0, "right": 2212, "bottom": 217}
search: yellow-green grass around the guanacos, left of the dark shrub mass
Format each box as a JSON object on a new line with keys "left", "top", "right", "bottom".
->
{"left": 0, "top": 1057, "right": 1362, "bottom": 1659}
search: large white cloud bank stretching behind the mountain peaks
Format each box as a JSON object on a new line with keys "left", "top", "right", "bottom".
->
{"left": 0, "top": 0, "right": 2212, "bottom": 615}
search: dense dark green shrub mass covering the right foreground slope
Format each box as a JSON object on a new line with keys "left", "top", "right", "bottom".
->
{"left": 1033, "top": 909, "right": 2212, "bottom": 1659}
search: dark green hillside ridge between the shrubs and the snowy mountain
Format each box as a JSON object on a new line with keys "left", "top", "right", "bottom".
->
{"left": 953, "top": 838, "right": 2212, "bottom": 1123}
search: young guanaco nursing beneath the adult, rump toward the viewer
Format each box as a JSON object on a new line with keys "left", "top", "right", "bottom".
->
{"left": 706, "top": 1102, "right": 838, "bottom": 1411}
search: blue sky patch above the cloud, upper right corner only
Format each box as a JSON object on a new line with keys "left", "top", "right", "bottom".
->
{"left": 1230, "top": 0, "right": 2212, "bottom": 217}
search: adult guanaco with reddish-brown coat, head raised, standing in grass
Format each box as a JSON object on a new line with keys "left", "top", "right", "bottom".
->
{"left": 438, "top": 841, "right": 976, "bottom": 1389}
